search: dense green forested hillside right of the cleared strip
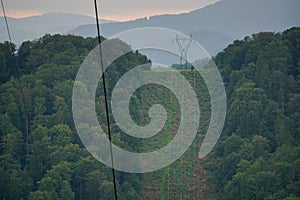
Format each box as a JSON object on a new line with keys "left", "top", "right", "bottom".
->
{"left": 207, "top": 28, "right": 300, "bottom": 199}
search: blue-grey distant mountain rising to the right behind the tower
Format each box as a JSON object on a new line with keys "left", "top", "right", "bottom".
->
{"left": 69, "top": 0, "right": 300, "bottom": 55}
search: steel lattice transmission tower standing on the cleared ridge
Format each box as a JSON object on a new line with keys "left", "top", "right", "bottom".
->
{"left": 176, "top": 35, "right": 193, "bottom": 69}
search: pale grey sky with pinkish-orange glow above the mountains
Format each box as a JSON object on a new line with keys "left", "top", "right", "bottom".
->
{"left": 0, "top": 0, "right": 218, "bottom": 21}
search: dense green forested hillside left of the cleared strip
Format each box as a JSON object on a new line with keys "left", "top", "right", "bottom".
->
{"left": 0, "top": 35, "right": 149, "bottom": 200}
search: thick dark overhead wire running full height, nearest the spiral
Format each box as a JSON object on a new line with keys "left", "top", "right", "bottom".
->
{"left": 94, "top": 0, "right": 118, "bottom": 200}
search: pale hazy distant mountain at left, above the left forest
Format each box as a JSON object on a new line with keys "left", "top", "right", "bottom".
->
{"left": 0, "top": 13, "right": 112, "bottom": 44}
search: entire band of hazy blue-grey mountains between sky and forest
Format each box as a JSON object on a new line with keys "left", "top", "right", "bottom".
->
{"left": 0, "top": 0, "right": 300, "bottom": 55}
